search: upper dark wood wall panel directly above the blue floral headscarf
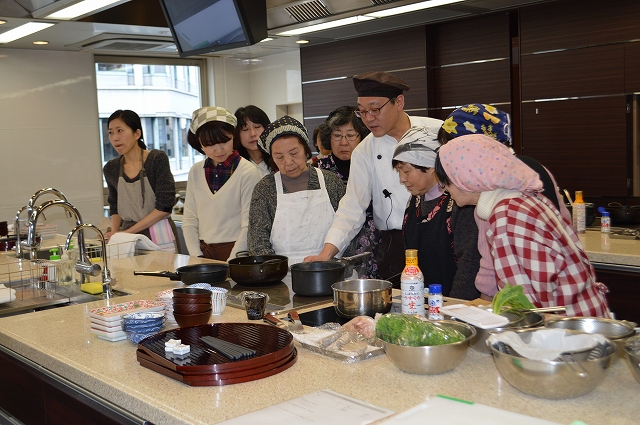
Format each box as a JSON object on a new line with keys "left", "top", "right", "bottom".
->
{"left": 433, "top": 13, "right": 510, "bottom": 66}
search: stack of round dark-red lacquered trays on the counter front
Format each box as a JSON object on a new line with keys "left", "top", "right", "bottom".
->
{"left": 136, "top": 323, "right": 297, "bottom": 386}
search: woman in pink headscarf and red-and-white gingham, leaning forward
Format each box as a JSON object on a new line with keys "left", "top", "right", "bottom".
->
{"left": 435, "top": 135, "right": 609, "bottom": 317}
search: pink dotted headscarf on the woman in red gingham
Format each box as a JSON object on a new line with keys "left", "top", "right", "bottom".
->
{"left": 438, "top": 134, "right": 542, "bottom": 192}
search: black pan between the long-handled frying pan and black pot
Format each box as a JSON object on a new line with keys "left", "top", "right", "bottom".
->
{"left": 229, "top": 255, "right": 289, "bottom": 285}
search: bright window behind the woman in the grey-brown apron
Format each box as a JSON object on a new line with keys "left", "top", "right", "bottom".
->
{"left": 96, "top": 57, "right": 205, "bottom": 182}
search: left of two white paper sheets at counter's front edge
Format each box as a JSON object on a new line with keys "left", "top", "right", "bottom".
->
{"left": 221, "top": 389, "right": 395, "bottom": 425}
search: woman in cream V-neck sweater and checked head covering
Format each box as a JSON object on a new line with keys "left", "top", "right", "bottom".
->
{"left": 182, "top": 106, "right": 260, "bottom": 261}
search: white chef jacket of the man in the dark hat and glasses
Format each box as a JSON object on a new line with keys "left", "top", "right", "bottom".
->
{"left": 325, "top": 116, "right": 442, "bottom": 255}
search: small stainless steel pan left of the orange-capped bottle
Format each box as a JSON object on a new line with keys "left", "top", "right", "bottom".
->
{"left": 331, "top": 279, "right": 393, "bottom": 319}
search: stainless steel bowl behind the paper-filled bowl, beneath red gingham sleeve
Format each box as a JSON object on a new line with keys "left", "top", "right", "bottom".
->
{"left": 545, "top": 317, "right": 636, "bottom": 361}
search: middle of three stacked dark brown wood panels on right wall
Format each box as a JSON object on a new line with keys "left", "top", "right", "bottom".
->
{"left": 520, "top": 44, "right": 624, "bottom": 101}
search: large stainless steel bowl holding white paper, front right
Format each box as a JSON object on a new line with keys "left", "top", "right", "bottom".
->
{"left": 491, "top": 329, "right": 617, "bottom": 399}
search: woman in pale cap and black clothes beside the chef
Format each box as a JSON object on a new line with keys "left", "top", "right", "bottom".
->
{"left": 393, "top": 127, "right": 480, "bottom": 300}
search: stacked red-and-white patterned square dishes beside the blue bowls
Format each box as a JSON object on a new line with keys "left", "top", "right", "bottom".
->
{"left": 89, "top": 300, "right": 164, "bottom": 341}
